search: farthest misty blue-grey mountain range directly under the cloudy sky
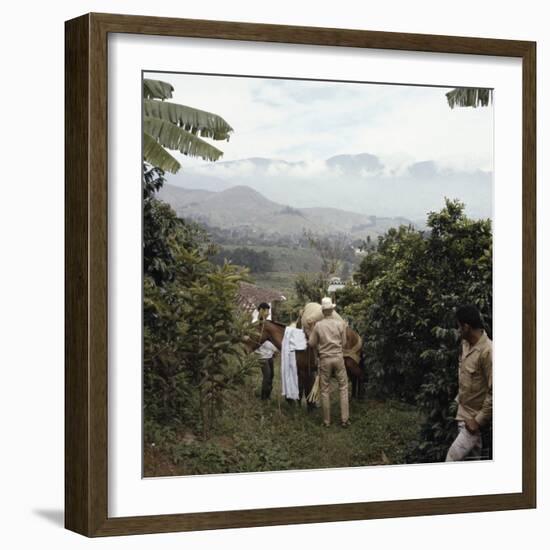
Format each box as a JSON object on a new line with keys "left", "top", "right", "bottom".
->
{"left": 167, "top": 153, "right": 493, "bottom": 225}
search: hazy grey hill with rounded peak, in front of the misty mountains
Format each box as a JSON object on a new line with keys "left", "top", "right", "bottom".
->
{"left": 158, "top": 184, "right": 411, "bottom": 238}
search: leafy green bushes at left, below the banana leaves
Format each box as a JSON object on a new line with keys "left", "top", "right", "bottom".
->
{"left": 143, "top": 167, "right": 251, "bottom": 442}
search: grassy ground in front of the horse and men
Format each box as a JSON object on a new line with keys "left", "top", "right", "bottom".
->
{"left": 144, "top": 365, "right": 422, "bottom": 477}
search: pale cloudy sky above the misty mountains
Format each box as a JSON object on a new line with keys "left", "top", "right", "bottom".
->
{"left": 145, "top": 73, "right": 493, "bottom": 172}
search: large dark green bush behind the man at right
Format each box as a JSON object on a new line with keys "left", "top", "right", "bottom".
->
{"left": 339, "top": 200, "right": 492, "bottom": 461}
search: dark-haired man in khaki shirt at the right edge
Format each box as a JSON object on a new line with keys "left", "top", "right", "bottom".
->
{"left": 446, "top": 306, "right": 493, "bottom": 462}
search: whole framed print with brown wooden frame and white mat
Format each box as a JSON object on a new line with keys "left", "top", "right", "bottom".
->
{"left": 65, "top": 14, "right": 536, "bottom": 536}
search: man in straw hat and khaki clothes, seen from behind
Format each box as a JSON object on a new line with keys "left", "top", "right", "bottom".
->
{"left": 308, "top": 298, "right": 350, "bottom": 428}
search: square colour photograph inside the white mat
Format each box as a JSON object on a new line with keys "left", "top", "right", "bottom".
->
{"left": 142, "top": 71, "right": 494, "bottom": 477}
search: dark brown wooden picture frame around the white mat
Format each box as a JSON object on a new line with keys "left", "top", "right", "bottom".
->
{"left": 65, "top": 14, "right": 536, "bottom": 537}
